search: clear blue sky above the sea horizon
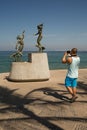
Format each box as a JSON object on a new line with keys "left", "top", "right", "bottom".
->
{"left": 0, "top": 0, "right": 87, "bottom": 51}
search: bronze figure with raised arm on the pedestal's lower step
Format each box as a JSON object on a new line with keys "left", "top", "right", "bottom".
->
{"left": 11, "top": 31, "right": 25, "bottom": 62}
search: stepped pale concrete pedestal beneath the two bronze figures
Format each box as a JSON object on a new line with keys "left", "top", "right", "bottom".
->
{"left": 8, "top": 53, "right": 50, "bottom": 81}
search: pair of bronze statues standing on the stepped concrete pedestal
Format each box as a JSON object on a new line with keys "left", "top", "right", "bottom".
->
{"left": 11, "top": 24, "right": 45, "bottom": 62}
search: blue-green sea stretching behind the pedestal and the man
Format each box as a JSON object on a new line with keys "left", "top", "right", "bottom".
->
{"left": 0, "top": 51, "right": 87, "bottom": 73}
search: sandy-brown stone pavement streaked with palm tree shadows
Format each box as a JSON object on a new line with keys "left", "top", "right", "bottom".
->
{"left": 0, "top": 70, "right": 87, "bottom": 130}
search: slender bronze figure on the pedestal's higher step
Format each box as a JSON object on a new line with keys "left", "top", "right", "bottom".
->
{"left": 35, "top": 24, "right": 45, "bottom": 52}
